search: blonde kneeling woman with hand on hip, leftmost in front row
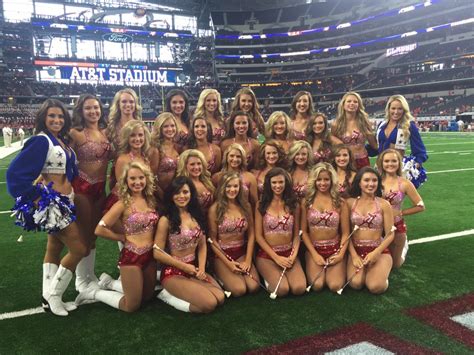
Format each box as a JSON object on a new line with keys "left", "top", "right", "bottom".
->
{"left": 76, "top": 162, "right": 158, "bottom": 312}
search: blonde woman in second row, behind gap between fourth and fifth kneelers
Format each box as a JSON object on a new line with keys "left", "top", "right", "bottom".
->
{"left": 288, "top": 141, "right": 313, "bottom": 201}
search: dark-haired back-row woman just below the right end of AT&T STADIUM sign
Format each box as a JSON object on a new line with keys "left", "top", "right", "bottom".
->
{"left": 165, "top": 89, "right": 189, "bottom": 152}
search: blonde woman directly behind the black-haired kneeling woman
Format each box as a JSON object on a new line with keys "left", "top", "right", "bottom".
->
{"left": 176, "top": 149, "right": 215, "bottom": 216}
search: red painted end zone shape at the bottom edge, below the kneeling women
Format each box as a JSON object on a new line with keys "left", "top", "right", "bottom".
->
{"left": 247, "top": 323, "right": 437, "bottom": 355}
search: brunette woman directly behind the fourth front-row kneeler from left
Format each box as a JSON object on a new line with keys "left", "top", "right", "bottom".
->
{"left": 252, "top": 139, "right": 287, "bottom": 197}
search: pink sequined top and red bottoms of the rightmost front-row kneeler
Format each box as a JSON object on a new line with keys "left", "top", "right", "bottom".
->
{"left": 351, "top": 197, "right": 390, "bottom": 258}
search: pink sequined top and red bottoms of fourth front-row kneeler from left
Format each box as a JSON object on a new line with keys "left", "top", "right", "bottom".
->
{"left": 257, "top": 212, "right": 295, "bottom": 260}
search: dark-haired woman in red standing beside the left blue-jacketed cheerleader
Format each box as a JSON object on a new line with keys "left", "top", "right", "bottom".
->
{"left": 69, "top": 94, "right": 111, "bottom": 291}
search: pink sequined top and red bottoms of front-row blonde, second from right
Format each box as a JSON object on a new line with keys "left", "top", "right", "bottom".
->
{"left": 307, "top": 207, "right": 341, "bottom": 259}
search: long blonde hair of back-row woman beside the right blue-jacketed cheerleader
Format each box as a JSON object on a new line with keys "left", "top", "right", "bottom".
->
{"left": 332, "top": 91, "right": 372, "bottom": 138}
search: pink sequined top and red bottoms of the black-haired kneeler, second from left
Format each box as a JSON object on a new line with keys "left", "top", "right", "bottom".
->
{"left": 160, "top": 227, "right": 203, "bottom": 284}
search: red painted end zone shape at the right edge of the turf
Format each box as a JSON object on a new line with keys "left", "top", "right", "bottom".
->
{"left": 406, "top": 293, "right": 474, "bottom": 348}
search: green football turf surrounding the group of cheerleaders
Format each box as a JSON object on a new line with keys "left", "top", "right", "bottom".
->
{"left": 0, "top": 133, "right": 474, "bottom": 354}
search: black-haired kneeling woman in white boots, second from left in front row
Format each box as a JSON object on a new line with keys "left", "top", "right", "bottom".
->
{"left": 154, "top": 176, "right": 224, "bottom": 313}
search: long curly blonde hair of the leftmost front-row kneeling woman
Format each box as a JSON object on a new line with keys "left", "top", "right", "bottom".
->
{"left": 118, "top": 161, "right": 156, "bottom": 209}
